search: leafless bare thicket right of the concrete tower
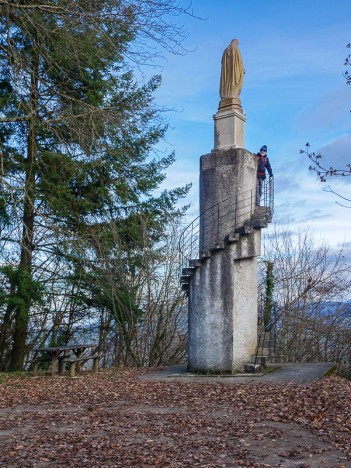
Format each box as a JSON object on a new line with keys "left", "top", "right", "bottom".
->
{"left": 261, "top": 226, "right": 351, "bottom": 374}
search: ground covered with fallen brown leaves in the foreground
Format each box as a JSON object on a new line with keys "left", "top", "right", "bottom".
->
{"left": 0, "top": 372, "right": 351, "bottom": 468}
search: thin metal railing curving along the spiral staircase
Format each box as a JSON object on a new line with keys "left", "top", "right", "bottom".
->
{"left": 179, "top": 178, "right": 274, "bottom": 272}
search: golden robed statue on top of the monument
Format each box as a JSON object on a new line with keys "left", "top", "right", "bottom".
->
{"left": 219, "top": 39, "right": 245, "bottom": 99}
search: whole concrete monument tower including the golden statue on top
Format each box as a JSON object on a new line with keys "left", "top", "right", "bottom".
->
{"left": 182, "top": 39, "right": 274, "bottom": 373}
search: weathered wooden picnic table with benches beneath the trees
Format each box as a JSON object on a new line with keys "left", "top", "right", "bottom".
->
{"left": 33, "top": 343, "right": 97, "bottom": 375}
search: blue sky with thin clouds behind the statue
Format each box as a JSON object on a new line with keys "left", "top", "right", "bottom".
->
{"left": 152, "top": 0, "right": 351, "bottom": 254}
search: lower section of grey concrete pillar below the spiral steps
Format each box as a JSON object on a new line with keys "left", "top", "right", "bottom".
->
{"left": 188, "top": 234, "right": 261, "bottom": 372}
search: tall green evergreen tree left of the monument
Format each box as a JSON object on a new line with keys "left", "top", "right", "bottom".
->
{"left": 0, "top": 0, "right": 191, "bottom": 369}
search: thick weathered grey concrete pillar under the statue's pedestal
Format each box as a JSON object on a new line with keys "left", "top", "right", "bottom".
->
{"left": 188, "top": 148, "right": 261, "bottom": 372}
